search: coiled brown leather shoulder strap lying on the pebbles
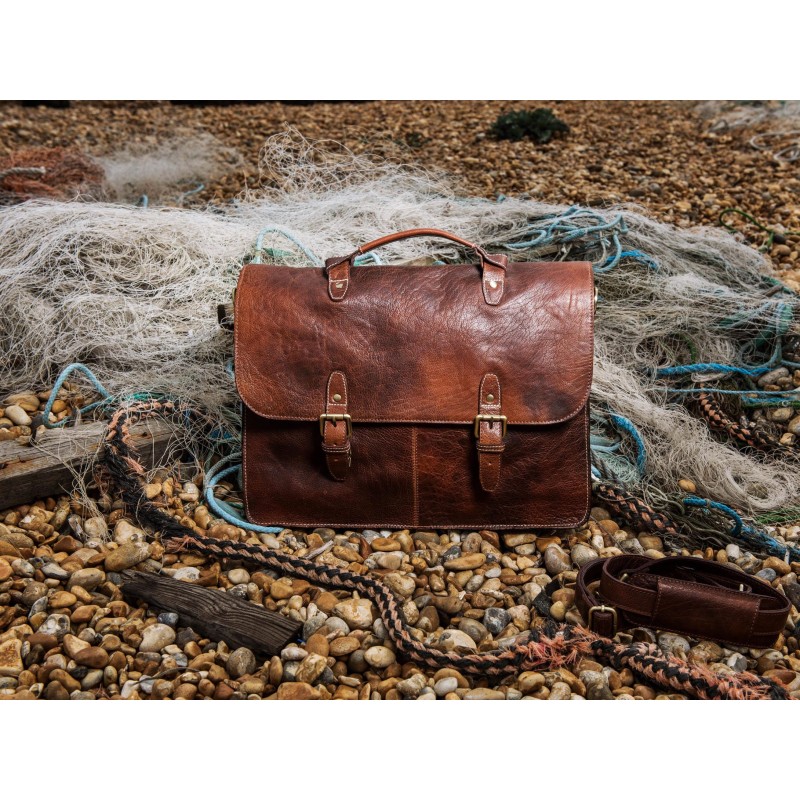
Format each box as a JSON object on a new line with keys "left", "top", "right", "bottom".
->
{"left": 575, "top": 555, "right": 791, "bottom": 648}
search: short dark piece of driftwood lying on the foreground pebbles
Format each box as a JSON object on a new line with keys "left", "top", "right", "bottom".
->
{"left": 120, "top": 570, "right": 301, "bottom": 656}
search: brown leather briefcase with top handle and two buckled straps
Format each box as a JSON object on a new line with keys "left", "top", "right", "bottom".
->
{"left": 234, "top": 229, "right": 594, "bottom": 530}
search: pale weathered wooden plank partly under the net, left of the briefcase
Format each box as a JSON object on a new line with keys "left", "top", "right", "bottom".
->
{"left": 0, "top": 419, "right": 171, "bottom": 509}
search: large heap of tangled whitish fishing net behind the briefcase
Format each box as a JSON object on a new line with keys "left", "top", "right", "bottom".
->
{"left": 0, "top": 131, "right": 800, "bottom": 513}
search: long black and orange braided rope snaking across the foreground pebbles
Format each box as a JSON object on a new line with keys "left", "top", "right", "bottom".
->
{"left": 98, "top": 399, "right": 788, "bottom": 699}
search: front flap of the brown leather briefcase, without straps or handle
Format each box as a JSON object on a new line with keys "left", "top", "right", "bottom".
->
{"left": 234, "top": 262, "right": 594, "bottom": 425}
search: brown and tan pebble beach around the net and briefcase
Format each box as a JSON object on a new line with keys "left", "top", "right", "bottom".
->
{"left": 0, "top": 101, "right": 800, "bottom": 700}
